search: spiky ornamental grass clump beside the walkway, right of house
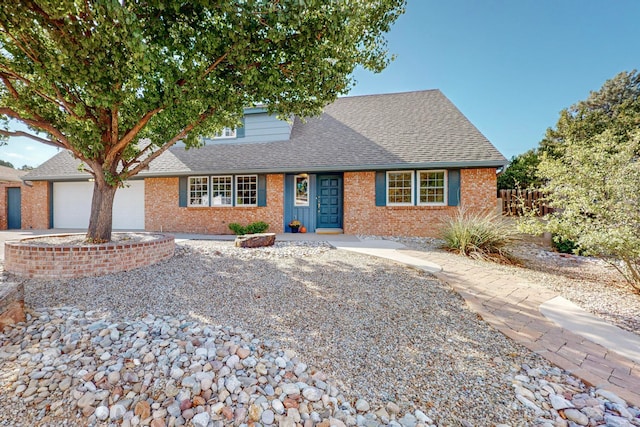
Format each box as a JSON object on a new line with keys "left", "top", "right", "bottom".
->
{"left": 441, "top": 210, "right": 516, "bottom": 261}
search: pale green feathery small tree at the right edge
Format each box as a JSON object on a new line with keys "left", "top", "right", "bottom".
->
{"left": 521, "top": 71, "right": 640, "bottom": 293}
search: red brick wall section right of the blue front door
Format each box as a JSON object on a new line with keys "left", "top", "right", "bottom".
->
{"left": 344, "top": 169, "right": 496, "bottom": 237}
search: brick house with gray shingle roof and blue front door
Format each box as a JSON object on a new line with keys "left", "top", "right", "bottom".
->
{"left": 13, "top": 90, "right": 507, "bottom": 236}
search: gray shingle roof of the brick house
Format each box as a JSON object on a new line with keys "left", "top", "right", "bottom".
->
{"left": 25, "top": 90, "right": 507, "bottom": 180}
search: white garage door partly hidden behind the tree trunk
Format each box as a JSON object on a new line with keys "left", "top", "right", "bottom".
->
{"left": 53, "top": 181, "right": 144, "bottom": 230}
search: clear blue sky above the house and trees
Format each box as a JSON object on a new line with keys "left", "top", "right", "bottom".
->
{"left": 0, "top": 0, "right": 640, "bottom": 167}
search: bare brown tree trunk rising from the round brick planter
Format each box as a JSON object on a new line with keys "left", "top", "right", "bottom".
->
{"left": 87, "top": 177, "right": 118, "bottom": 243}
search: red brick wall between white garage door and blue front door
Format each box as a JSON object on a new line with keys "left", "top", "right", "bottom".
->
{"left": 144, "top": 174, "right": 284, "bottom": 234}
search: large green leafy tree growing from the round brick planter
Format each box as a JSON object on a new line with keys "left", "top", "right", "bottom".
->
{"left": 0, "top": 0, "right": 405, "bottom": 241}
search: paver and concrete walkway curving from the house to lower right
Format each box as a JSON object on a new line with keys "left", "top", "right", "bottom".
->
{"left": 331, "top": 241, "right": 640, "bottom": 406}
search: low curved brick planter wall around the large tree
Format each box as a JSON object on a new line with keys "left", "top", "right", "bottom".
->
{"left": 4, "top": 234, "right": 175, "bottom": 279}
